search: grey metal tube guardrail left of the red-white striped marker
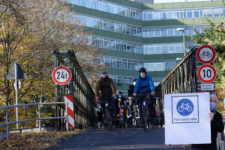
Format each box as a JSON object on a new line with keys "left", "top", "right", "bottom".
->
{"left": 0, "top": 102, "right": 68, "bottom": 141}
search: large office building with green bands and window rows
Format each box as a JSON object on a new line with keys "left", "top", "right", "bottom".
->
{"left": 66, "top": 0, "right": 225, "bottom": 93}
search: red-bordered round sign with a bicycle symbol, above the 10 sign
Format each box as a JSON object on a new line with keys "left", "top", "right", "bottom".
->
{"left": 197, "top": 45, "right": 216, "bottom": 63}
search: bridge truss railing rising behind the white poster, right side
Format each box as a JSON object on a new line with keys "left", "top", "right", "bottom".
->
{"left": 156, "top": 46, "right": 204, "bottom": 110}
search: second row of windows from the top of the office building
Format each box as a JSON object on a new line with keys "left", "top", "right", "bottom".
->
{"left": 78, "top": 15, "right": 207, "bottom": 38}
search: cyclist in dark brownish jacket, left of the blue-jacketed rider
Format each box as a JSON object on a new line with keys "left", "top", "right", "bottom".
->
{"left": 95, "top": 71, "right": 116, "bottom": 128}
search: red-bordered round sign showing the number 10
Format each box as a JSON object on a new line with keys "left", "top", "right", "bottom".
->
{"left": 198, "top": 65, "right": 216, "bottom": 83}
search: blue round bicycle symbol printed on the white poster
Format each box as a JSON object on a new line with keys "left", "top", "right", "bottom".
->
{"left": 177, "top": 99, "right": 194, "bottom": 116}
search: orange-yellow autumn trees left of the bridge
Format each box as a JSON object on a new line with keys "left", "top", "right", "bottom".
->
{"left": 0, "top": 0, "right": 96, "bottom": 126}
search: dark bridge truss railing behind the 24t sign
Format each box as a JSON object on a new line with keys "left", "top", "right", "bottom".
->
{"left": 52, "top": 50, "right": 97, "bottom": 130}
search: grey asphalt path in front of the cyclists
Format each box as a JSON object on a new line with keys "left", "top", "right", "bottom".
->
{"left": 46, "top": 128, "right": 190, "bottom": 150}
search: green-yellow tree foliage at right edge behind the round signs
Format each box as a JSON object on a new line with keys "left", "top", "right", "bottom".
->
{"left": 192, "top": 20, "right": 225, "bottom": 112}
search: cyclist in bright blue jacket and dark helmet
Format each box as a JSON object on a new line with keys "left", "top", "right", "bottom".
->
{"left": 133, "top": 67, "right": 155, "bottom": 122}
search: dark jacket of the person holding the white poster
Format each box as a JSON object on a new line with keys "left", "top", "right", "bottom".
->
{"left": 192, "top": 111, "right": 224, "bottom": 150}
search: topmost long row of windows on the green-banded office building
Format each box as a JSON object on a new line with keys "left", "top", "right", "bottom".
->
{"left": 61, "top": 0, "right": 225, "bottom": 21}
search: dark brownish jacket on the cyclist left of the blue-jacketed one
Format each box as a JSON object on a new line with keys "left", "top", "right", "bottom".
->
{"left": 95, "top": 77, "right": 116, "bottom": 96}
